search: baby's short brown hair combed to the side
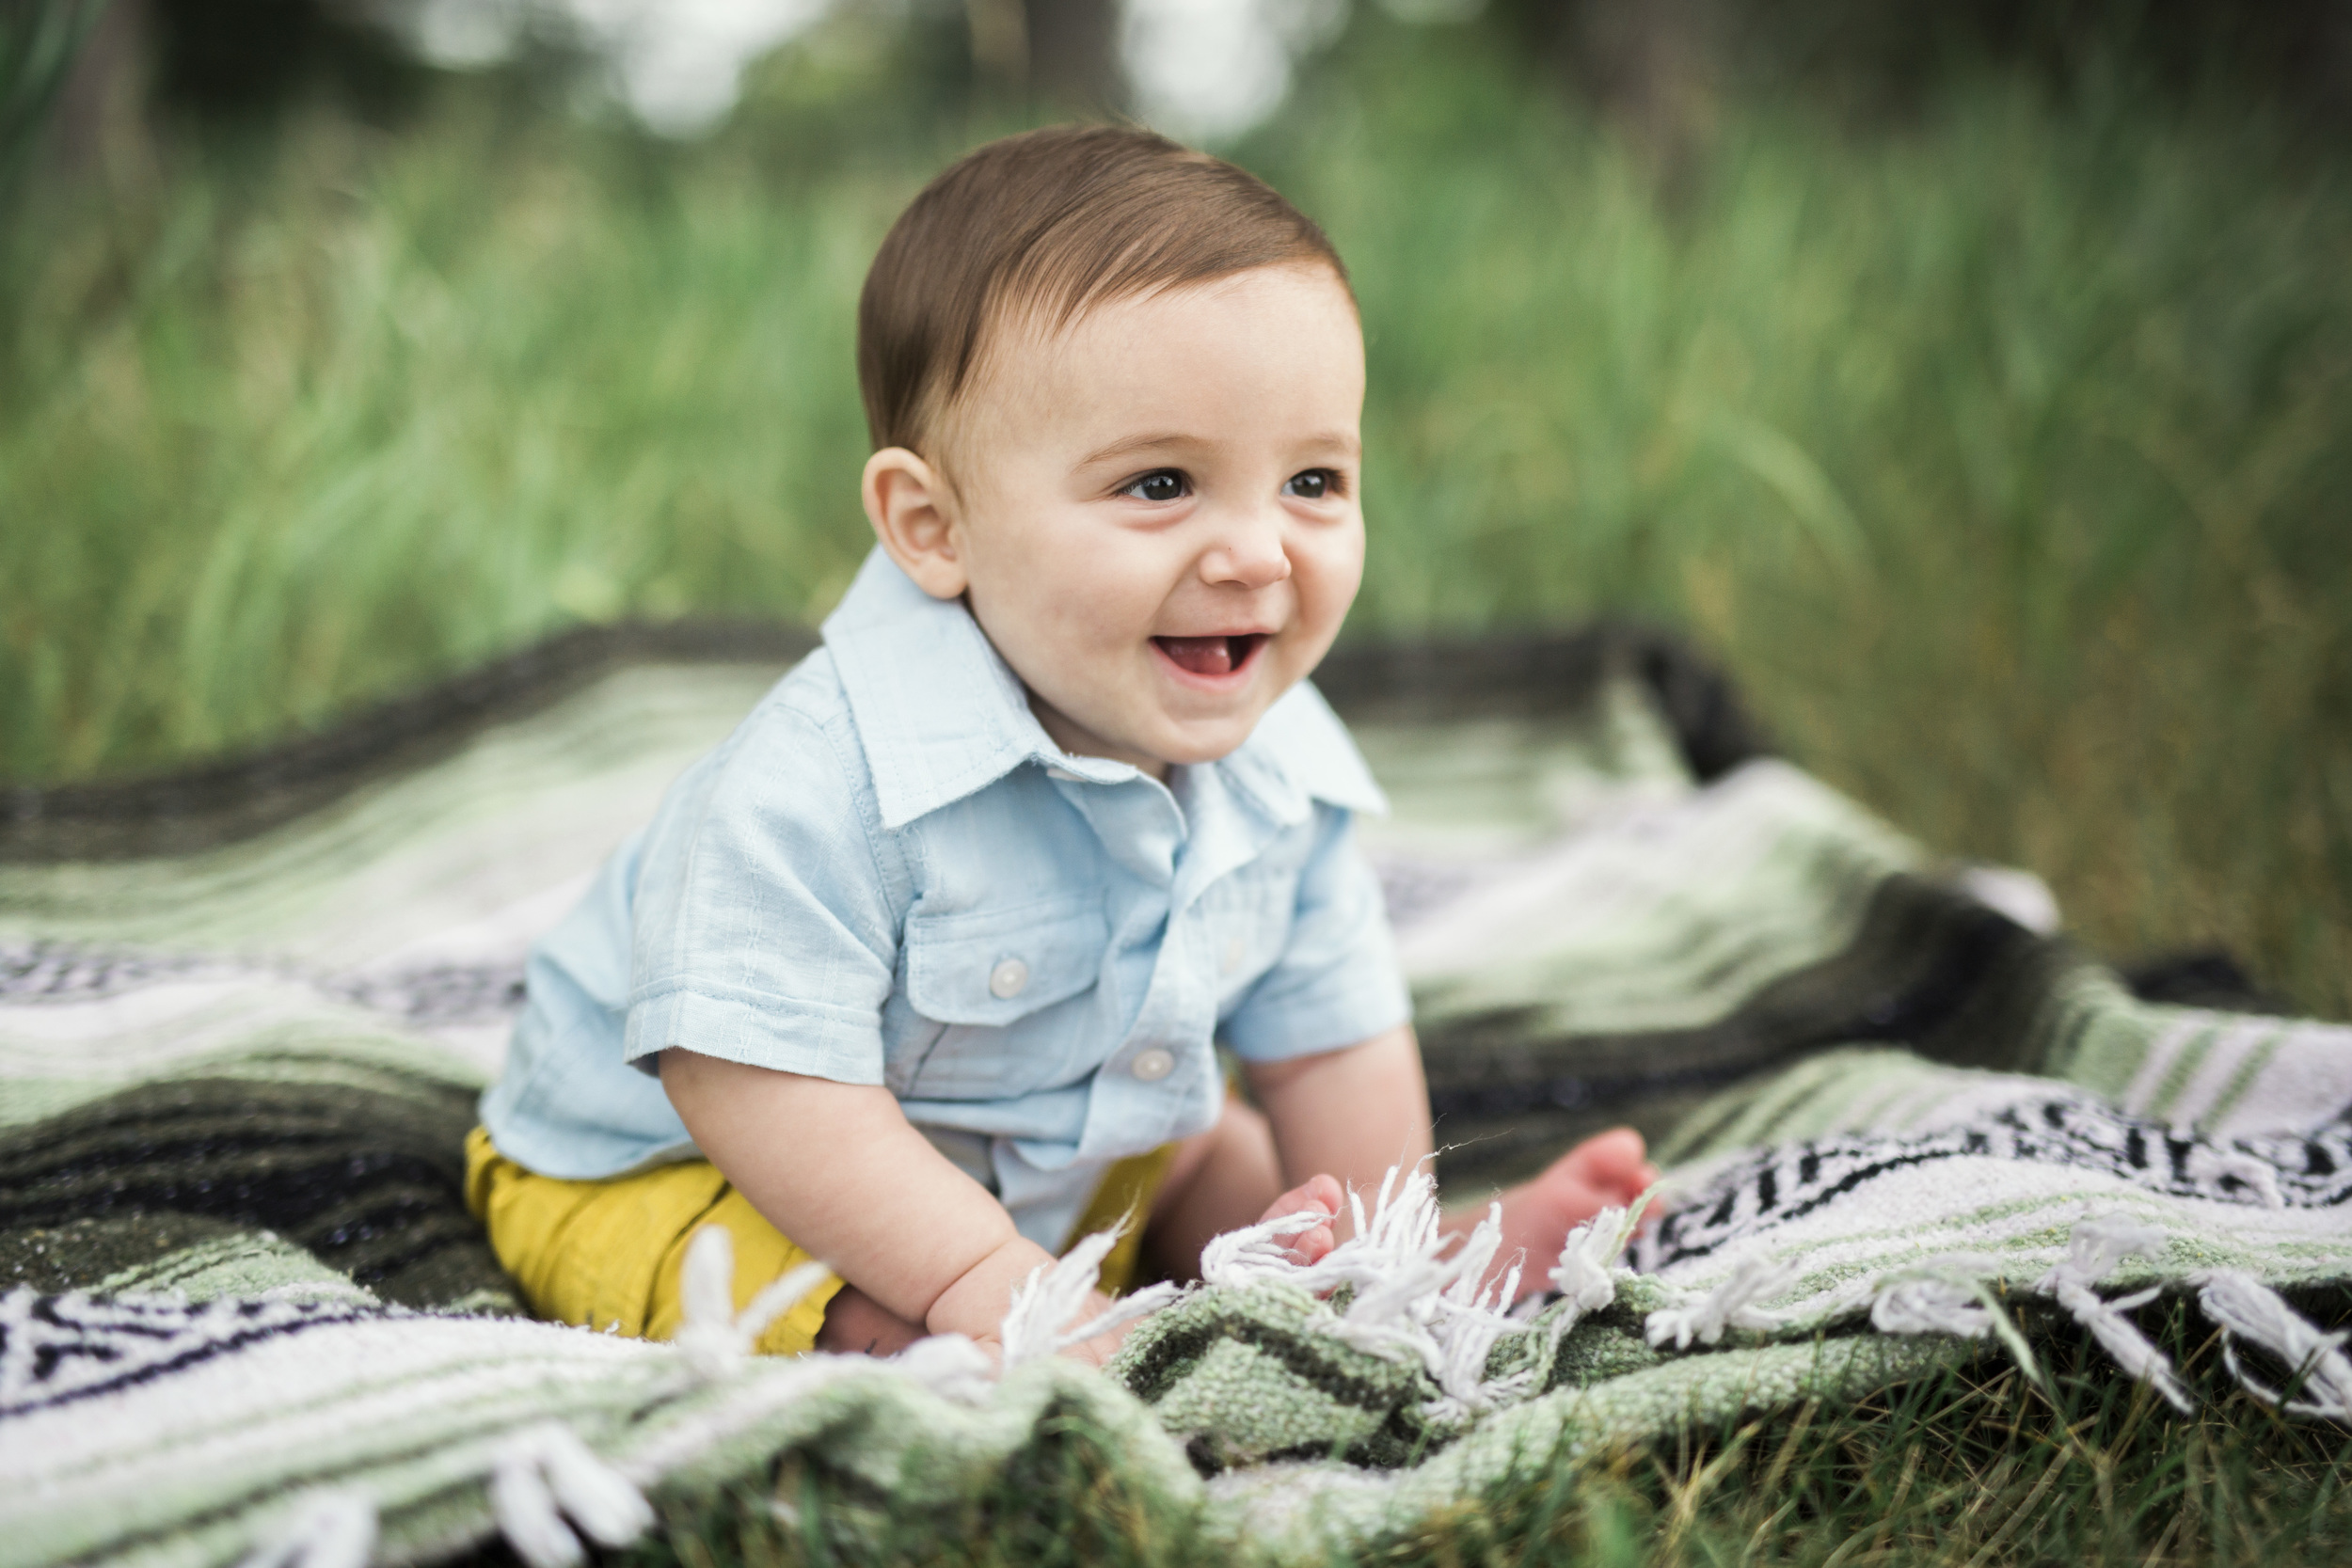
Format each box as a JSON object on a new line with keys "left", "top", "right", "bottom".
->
{"left": 859, "top": 124, "right": 1348, "bottom": 461}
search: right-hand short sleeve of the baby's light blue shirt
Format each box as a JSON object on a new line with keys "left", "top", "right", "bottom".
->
{"left": 1223, "top": 804, "right": 1414, "bottom": 1063}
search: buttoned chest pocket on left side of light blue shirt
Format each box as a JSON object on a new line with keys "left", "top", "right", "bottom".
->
{"left": 906, "top": 895, "right": 1110, "bottom": 1027}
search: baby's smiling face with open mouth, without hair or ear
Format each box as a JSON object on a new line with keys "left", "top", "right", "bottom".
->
{"left": 927, "top": 265, "right": 1364, "bottom": 776}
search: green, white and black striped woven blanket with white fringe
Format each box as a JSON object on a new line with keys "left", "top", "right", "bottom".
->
{"left": 0, "top": 627, "right": 2352, "bottom": 1568}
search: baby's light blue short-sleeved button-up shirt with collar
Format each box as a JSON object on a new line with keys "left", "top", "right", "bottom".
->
{"left": 468, "top": 550, "right": 1411, "bottom": 1248}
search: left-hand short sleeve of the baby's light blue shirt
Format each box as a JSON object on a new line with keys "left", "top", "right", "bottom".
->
{"left": 624, "top": 703, "right": 898, "bottom": 1084}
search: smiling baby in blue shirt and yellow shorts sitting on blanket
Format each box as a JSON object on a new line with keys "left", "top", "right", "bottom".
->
{"left": 469, "top": 127, "right": 1654, "bottom": 1356}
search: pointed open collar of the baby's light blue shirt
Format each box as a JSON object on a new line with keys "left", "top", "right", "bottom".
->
{"left": 823, "top": 546, "right": 1388, "bottom": 830}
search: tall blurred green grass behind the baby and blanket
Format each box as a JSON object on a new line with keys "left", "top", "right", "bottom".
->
{"left": 0, "top": 16, "right": 2352, "bottom": 1016}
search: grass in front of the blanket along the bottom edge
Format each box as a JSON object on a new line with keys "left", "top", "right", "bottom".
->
{"left": 628, "top": 1309, "right": 2352, "bottom": 1568}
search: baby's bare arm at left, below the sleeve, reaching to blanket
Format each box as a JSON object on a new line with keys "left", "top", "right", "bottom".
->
{"left": 661, "top": 1049, "right": 1101, "bottom": 1340}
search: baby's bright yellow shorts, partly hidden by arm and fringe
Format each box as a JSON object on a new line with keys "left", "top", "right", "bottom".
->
{"left": 466, "top": 1126, "right": 1176, "bottom": 1356}
